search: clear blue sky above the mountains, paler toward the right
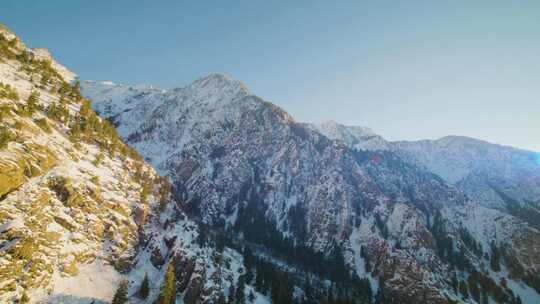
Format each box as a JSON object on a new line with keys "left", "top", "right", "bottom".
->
{"left": 0, "top": 0, "right": 540, "bottom": 151}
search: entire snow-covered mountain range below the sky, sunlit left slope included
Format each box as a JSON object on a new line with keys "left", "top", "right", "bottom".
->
{"left": 0, "top": 21, "right": 540, "bottom": 304}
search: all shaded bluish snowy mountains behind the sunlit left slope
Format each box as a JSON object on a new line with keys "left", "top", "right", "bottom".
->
{"left": 82, "top": 74, "right": 540, "bottom": 303}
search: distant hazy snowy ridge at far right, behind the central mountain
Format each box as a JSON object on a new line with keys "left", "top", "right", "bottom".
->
{"left": 311, "top": 123, "right": 540, "bottom": 223}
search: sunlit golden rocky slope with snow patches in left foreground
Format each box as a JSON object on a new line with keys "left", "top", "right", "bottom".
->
{"left": 0, "top": 27, "right": 258, "bottom": 303}
